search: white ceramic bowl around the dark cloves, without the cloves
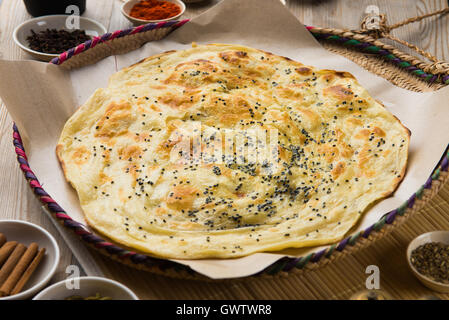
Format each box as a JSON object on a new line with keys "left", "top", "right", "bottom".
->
{"left": 13, "top": 15, "right": 107, "bottom": 61}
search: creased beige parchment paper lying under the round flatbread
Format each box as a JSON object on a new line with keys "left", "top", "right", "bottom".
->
{"left": 0, "top": 0, "right": 449, "bottom": 279}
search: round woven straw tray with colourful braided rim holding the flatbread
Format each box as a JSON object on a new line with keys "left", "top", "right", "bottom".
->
{"left": 13, "top": 20, "right": 449, "bottom": 280}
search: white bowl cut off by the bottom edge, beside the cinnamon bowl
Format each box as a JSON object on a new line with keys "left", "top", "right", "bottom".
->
{"left": 33, "top": 277, "right": 139, "bottom": 300}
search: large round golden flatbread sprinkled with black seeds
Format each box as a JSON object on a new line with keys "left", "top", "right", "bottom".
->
{"left": 56, "top": 44, "right": 410, "bottom": 259}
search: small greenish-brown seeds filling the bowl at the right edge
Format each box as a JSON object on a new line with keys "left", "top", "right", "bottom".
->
{"left": 410, "top": 242, "right": 449, "bottom": 283}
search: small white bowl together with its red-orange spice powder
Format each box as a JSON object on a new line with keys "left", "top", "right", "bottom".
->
{"left": 122, "top": 0, "right": 186, "bottom": 25}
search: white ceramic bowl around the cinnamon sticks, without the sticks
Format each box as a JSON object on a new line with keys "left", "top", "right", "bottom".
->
{"left": 0, "top": 220, "right": 59, "bottom": 300}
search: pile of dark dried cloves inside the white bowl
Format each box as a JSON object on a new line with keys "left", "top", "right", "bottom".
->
{"left": 27, "top": 29, "right": 91, "bottom": 53}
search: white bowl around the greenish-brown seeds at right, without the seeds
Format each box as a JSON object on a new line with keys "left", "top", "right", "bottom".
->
{"left": 407, "top": 231, "right": 449, "bottom": 292}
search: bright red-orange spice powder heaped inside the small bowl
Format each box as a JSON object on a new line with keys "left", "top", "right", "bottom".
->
{"left": 129, "top": 0, "right": 181, "bottom": 20}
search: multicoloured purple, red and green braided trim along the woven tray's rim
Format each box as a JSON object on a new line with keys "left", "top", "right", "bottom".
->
{"left": 13, "top": 20, "right": 449, "bottom": 275}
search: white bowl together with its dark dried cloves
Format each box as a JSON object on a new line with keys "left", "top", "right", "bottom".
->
{"left": 13, "top": 15, "right": 107, "bottom": 61}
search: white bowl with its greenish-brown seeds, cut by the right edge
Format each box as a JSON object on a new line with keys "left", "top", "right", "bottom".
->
{"left": 407, "top": 231, "right": 449, "bottom": 293}
